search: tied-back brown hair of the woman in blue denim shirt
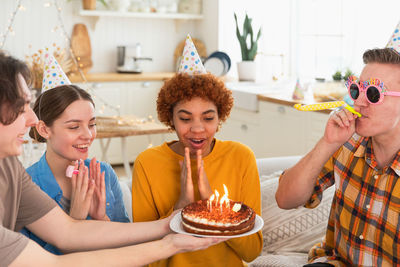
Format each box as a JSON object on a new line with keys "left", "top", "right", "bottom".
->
{"left": 29, "top": 85, "right": 94, "bottom": 143}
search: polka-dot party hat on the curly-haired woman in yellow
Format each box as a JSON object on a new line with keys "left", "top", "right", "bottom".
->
{"left": 178, "top": 34, "right": 207, "bottom": 75}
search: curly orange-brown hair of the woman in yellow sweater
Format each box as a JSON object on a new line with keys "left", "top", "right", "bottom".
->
{"left": 157, "top": 73, "right": 233, "bottom": 129}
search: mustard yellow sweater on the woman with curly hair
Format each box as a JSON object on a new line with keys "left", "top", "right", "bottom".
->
{"left": 132, "top": 140, "right": 263, "bottom": 267}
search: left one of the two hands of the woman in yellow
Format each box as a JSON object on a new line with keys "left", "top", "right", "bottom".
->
{"left": 174, "top": 147, "right": 194, "bottom": 210}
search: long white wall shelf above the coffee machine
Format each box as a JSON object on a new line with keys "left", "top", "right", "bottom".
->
{"left": 79, "top": 9, "right": 203, "bottom": 19}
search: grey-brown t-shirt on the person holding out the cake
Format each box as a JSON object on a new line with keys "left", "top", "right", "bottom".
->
{"left": 0, "top": 157, "right": 57, "bottom": 266}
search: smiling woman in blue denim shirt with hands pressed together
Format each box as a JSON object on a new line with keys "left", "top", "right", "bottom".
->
{"left": 22, "top": 85, "right": 129, "bottom": 254}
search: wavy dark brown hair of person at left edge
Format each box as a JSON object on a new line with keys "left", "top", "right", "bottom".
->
{"left": 0, "top": 50, "right": 31, "bottom": 125}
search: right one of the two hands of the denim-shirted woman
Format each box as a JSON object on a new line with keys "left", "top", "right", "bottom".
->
{"left": 89, "top": 158, "right": 110, "bottom": 221}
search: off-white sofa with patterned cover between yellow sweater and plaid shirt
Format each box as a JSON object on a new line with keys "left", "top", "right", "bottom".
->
{"left": 120, "top": 156, "right": 334, "bottom": 267}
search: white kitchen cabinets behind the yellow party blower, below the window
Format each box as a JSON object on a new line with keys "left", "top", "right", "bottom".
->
{"left": 217, "top": 101, "right": 328, "bottom": 158}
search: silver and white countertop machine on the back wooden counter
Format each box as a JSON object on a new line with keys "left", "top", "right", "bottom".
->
{"left": 117, "top": 43, "right": 153, "bottom": 73}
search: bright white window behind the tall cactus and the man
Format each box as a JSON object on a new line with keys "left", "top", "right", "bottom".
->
{"left": 219, "top": 0, "right": 400, "bottom": 79}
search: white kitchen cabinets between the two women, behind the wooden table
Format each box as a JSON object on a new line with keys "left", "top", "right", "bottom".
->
{"left": 77, "top": 81, "right": 175, "bottom": 164}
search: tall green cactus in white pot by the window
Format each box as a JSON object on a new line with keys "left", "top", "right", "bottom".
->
{"left": 234, "top": 13, "right": 261, "bottom": 81}
